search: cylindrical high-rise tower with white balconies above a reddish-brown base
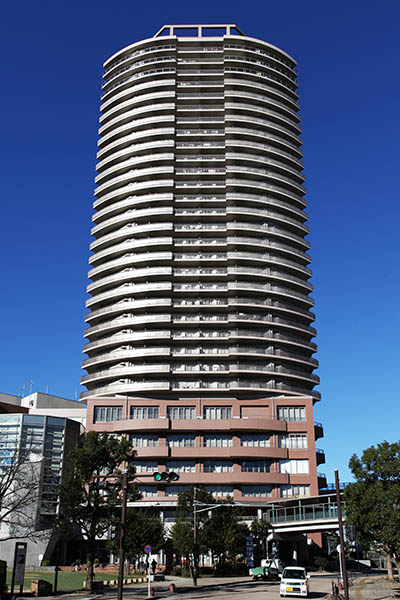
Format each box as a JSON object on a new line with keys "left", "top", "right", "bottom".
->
{"left": 81, "top": 25, "right": 323, "bottom": 501}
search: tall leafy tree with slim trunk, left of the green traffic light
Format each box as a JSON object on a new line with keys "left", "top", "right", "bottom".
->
{"left": 58, "top": 431, "right": 140, "bottom": 591}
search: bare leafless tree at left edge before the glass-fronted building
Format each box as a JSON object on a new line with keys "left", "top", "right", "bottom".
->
{"left": 0, "top": 432, "right": 42, "bottom": 541}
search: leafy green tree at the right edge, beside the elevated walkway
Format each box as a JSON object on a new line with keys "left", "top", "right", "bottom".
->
{"left": 344, "top": 441, "right": 400, "bottom": 581}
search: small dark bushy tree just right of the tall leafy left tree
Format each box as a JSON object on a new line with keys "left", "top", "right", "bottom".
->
{"left": 108, "top": 508, "right": 166, "bottom": 562}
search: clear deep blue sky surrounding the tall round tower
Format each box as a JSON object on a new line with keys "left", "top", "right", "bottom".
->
{"left": 0, "top": 0, "right": 400, "bottom": 481}
